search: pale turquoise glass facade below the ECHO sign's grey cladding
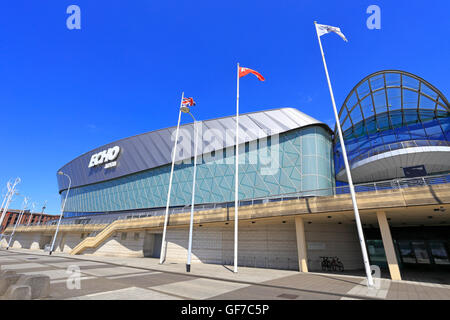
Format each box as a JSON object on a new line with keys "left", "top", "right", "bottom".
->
{"left": 61, "top": 125, "right": 335, "bottom": 217}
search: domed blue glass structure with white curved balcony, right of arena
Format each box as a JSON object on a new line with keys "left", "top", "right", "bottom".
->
{"left": 335, "top": 70, "right": 450, "bottom": 182}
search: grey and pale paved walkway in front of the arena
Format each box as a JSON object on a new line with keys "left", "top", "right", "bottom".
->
{"left": 0, "top": 249, "right": 450, "bottom": 300}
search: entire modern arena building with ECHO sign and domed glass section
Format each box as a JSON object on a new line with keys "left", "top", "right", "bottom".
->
{"left": 2, "top": 70, "right": 450, "bottom": 279}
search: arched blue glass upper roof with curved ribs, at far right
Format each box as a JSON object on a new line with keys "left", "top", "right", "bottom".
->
{"left": 335, "top": 70, "right": 450, "bottom": 139}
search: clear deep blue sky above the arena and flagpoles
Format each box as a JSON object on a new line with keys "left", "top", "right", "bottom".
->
{"left": 0, "top": 0, "right": 450, "bottom": 214}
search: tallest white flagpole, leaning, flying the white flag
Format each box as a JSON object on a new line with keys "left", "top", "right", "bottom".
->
{"left": 314, "top": 21, "right": 373, "bottom": 287}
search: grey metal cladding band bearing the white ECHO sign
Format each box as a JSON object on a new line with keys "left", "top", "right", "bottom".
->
{"left": 57, "top": 108, "right": 324, "bottom": 192}
